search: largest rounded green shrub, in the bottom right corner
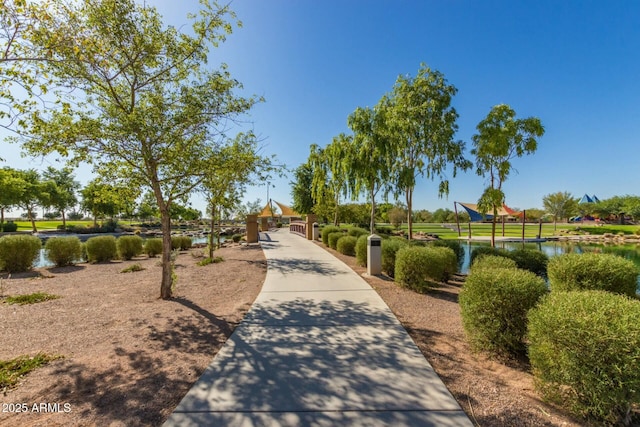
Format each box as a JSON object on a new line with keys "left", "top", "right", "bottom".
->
{"left": 529, "top": 291, "right": 640, "bottom": 425}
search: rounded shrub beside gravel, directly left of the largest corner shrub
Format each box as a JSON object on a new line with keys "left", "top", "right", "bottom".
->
{"left": 459, "top": 268, "right": 547, "bottom": 355}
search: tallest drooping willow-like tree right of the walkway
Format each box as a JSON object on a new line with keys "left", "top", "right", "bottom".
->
{"left": 387, "top": 64, "right": 472, "bottom": 239}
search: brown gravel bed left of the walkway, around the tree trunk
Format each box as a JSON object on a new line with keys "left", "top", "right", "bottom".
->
{"left": 0, "top": 245, "right": 266, "bottom": 426}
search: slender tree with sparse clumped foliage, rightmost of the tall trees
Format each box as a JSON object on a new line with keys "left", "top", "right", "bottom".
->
{"left": 471, "top": 104, "right": 544, "bottom": 246}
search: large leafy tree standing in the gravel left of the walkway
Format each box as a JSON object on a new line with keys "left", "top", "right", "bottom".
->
{"left": 11, "top": 0, "right": 258, "bottom": 299}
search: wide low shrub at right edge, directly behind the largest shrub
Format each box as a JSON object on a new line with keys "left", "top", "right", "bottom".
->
{"left": 548, "top": 253, "right": 638, "bottom": 296}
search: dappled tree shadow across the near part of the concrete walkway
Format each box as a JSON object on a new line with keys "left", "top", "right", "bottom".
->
{"left": 172, "top": 298, "right": 464, "bottom": 425}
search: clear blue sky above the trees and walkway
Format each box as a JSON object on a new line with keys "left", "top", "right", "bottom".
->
{"left": 2, "top": 0, "right": 640, "bottom": 214}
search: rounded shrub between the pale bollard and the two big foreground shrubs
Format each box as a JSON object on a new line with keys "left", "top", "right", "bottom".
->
{"left": 394, "top": 245, "right": 457, "bottom": 292}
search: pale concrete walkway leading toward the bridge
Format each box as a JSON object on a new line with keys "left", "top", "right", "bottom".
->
{"left": 165, "top": 229, "right": 472, "bottom": 427}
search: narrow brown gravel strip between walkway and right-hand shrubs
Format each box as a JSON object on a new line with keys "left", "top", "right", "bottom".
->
{"left": 314, "top": 242, "right": 585, "bottom": 427}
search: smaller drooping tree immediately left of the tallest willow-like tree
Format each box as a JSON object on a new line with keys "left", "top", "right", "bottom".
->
{"left": 345, "top": 103, "right": 395, "bottom": 233}
